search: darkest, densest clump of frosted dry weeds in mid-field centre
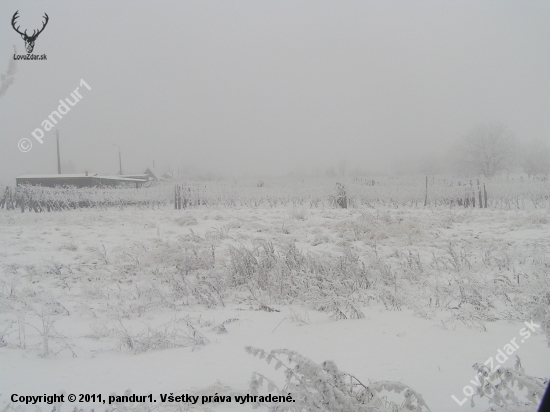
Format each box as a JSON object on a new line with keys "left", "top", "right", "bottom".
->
{"left": 229, "top": 242, "right": 370, "bottom": 319}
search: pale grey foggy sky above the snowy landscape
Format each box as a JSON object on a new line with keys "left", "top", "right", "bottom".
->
{"left": 0, "top": 0, "right": 550, "bottom": 185}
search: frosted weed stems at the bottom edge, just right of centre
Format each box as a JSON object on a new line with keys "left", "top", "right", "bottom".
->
{"left": 246, "top": 346, "right": 430, "bottom": 412}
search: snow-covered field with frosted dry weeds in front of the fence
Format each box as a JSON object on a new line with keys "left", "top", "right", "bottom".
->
{"left": 0, "top": 207, "right": 550, "bottom": 411}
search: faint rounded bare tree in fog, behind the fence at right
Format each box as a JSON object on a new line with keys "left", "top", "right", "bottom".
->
{"left": 457, "top": 124, "right": 518, "bottom": 177}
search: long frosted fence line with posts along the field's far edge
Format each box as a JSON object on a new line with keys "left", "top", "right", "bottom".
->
{"left": 0, "top": 177, "right": 550, "bottom": 212}
